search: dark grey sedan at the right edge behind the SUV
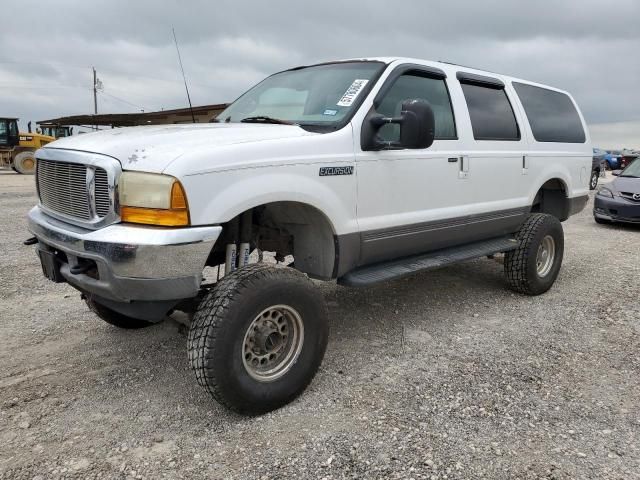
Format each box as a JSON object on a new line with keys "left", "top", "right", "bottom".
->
{"left": 593, "top": 161, "right": 640, "bottom": 224}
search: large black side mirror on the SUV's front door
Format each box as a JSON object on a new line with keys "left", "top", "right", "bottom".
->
{"left": 361, "top": 99, "right": 435, "bottom": 150}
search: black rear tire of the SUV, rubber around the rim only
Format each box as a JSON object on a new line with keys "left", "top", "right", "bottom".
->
{"left": 504, "top": 213, "right": 564, "bottom": 295}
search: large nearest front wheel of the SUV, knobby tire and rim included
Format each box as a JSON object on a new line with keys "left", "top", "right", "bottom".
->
{"left": 188, "top": 263, "right": 328, "bottom": 415}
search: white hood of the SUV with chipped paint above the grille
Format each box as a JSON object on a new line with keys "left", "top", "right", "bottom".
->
{"left": 45, "top": 123, "right": 318, "bottom": 172}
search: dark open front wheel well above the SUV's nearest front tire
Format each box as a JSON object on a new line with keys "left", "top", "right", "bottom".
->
{"left": 207, "top": 202, "right": 337, "bottom": 280}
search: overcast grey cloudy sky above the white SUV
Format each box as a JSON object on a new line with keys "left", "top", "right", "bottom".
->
{"left": 0, "top": 0, "right": 640, "bottom": 148}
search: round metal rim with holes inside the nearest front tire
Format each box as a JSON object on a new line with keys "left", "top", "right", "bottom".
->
{"left": 242, "top": 305, "right": 304, "bottom": 382}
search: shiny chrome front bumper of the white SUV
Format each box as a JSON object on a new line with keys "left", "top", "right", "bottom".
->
{"left": 28, "top": 207, "right": 222, "bottom": 302}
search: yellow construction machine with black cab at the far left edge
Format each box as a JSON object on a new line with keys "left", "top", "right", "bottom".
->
{"left": 0, "top": 117, "right": 55, "bottom": 175}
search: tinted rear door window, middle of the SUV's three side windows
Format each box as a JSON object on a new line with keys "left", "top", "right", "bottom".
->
{"left": 460, "top": 81, "right": 520, "bottom": 140}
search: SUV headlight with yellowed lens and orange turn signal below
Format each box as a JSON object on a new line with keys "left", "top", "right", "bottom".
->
{"left": 119, "top": 172, "right": 189, "bottom": 227}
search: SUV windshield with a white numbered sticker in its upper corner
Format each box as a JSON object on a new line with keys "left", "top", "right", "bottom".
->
{"left": 216, "top": 62, "right": 384, "bottom": 127}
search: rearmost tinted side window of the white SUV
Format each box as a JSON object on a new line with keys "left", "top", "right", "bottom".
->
{"left": 513, "top": 82, "right": 586, "bottom": 143}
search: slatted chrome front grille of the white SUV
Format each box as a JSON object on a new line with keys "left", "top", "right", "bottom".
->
{"left": 36, "top": 159, "right": 111, "bottom": 222}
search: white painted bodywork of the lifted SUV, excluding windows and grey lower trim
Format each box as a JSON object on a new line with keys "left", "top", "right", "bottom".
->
{"left": 38, "top": 59, "right": 592, "bottom": 240}
